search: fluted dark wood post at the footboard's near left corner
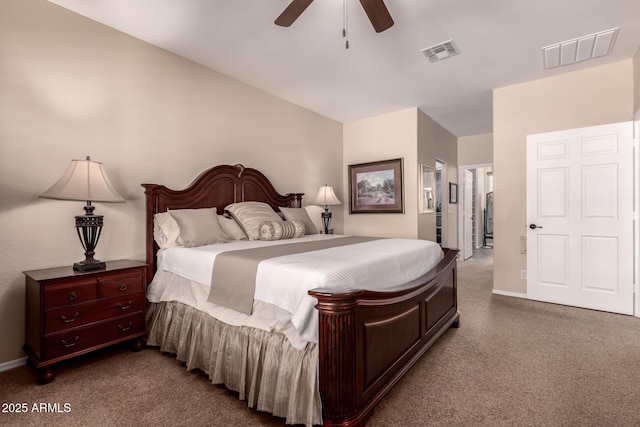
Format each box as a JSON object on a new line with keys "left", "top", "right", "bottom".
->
{"left": 310, "top": 290, "right": 364, "bottom": 426}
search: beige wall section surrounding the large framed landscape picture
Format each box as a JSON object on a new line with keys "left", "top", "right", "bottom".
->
{"left": 341, "top": 108, "right": 418, "bottom": 238}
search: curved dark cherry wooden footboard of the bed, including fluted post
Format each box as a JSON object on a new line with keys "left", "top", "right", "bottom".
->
{"left": 309, "top": 249, "right": 459, "bottom": 426}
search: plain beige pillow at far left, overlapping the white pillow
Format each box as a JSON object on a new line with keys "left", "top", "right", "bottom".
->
{"left": 169, "top": 208, "right": 229, "bottom": 247}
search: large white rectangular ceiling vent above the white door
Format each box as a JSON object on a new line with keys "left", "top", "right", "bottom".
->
{"left": 542, "top": 27, "right": 620, "bottom": 69}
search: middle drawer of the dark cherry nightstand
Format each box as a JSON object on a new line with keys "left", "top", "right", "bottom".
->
{"left": 44, "top": 293, "right": 146, "bottom": 334}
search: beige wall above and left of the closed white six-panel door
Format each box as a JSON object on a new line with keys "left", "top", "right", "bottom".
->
{"left": 493, "top": 59, "right": 634, "bottom": 294}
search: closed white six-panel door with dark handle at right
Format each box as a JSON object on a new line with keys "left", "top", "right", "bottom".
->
{"left": 526, "top": 122, "right": 634, "bottom": 314}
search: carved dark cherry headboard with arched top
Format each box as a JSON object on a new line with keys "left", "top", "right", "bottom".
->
{"left": 142, "top": 165, "right": 304, "bottom": 280}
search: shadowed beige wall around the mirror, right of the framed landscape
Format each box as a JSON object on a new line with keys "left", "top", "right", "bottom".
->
{"left": 416, "top": 110, "right": 460, "bottom": 248}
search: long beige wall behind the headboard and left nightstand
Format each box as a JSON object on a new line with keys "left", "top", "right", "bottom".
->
{"left": 0, "top": 0, "right": 344, "bottom": 363}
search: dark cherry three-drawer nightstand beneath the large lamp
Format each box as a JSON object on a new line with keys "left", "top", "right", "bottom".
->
{"left": 24, "top": 260, "right": 147, "bottom": 384}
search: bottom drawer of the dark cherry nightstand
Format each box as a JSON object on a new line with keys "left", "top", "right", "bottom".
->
{"left": 45, "top": 312, "right": 145, "bottom": 359}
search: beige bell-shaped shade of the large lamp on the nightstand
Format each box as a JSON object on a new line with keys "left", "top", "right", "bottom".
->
{"left": 40, "top": 156, "right": 125, "bottom": 202}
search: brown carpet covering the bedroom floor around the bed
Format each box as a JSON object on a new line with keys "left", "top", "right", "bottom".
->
{"left": 0, "top": 249, "right": 640, "bottom": 426}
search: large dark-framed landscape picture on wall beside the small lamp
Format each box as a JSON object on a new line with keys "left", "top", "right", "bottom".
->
{"left": 349, "top": 159, "right": 404, "bottom": 214}
